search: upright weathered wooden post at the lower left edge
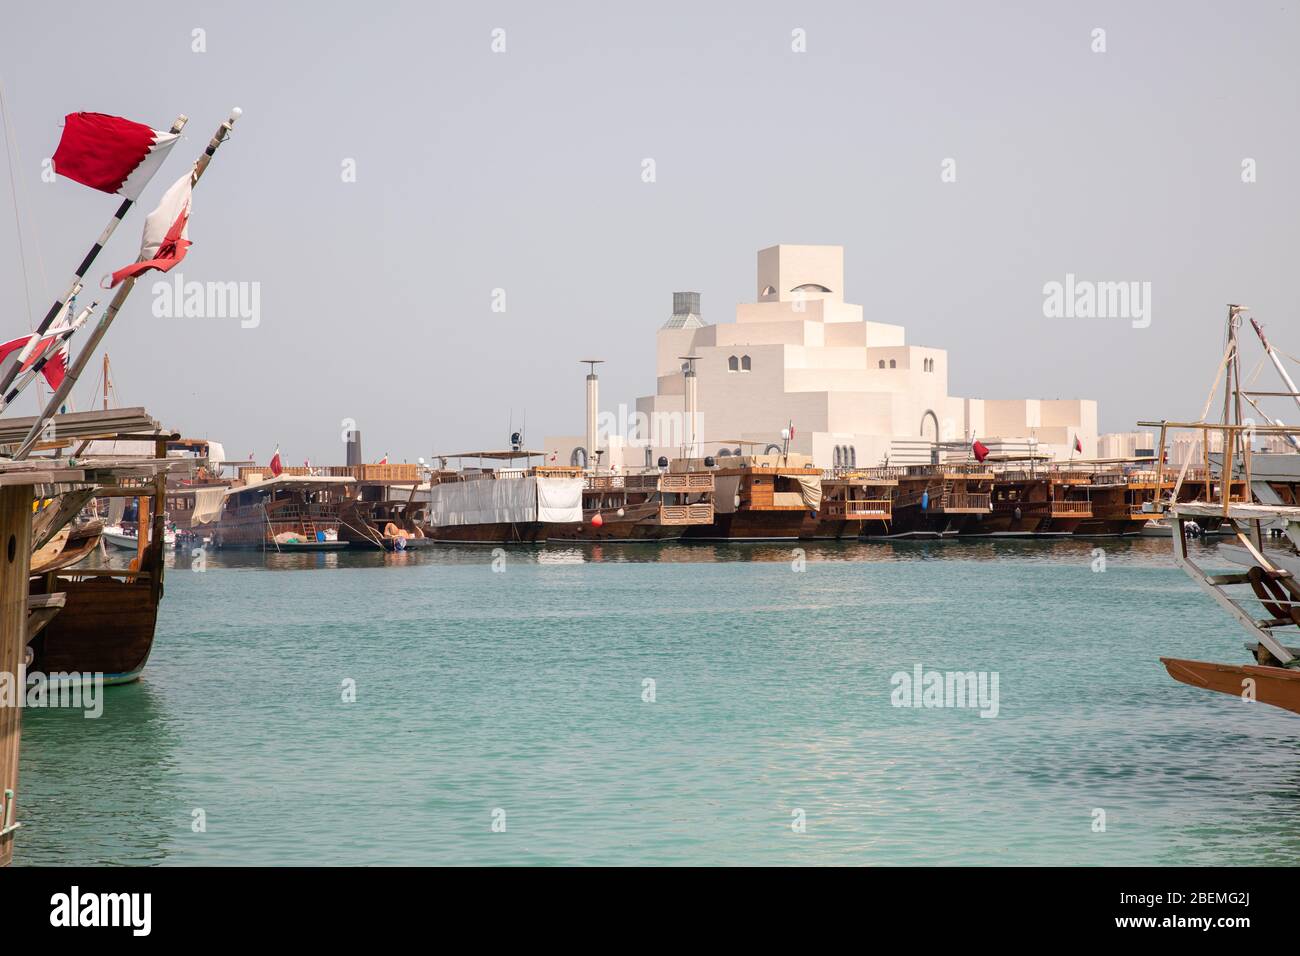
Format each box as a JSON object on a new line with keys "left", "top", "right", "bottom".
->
{"left": 0, "top": 485, "right": 35, "bottom": 866}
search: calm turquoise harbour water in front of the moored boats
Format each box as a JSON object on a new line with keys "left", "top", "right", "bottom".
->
{"left": 16, "top": 540, "right": 1300, "bottom": 865}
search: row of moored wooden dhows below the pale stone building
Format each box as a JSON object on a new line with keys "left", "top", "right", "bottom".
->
{"left": 169, "top": 449, "right": 1247, "bottom": 551}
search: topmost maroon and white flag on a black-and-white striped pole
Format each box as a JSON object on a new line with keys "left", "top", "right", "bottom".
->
{"left": 55, "top": 113, "right": 181, "bottom": 200}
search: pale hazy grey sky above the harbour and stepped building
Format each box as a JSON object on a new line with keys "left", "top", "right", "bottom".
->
{"left": 0, "top": 0, "right": 1300, "bottom": 463}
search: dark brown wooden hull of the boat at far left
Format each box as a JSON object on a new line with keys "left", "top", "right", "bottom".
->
{"left": 30, "top": 576, "right": 157, "bottom": 684}
